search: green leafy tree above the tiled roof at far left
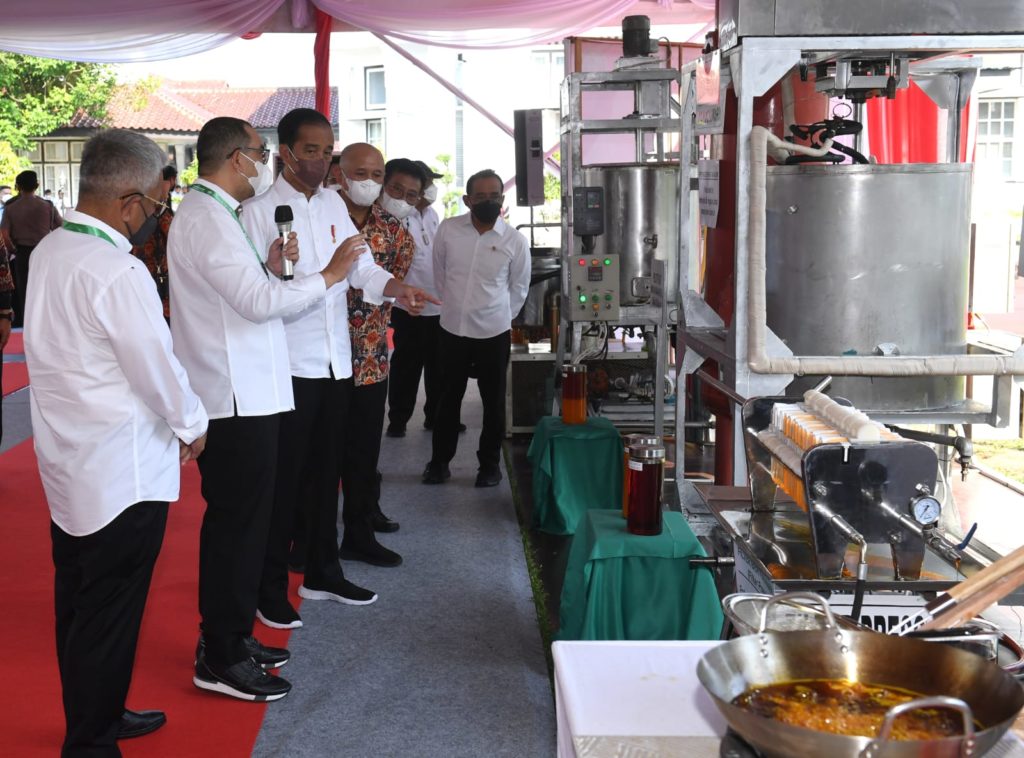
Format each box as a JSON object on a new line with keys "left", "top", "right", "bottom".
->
{"left": 0, "top": 52, "right": 116, "bottom": 150}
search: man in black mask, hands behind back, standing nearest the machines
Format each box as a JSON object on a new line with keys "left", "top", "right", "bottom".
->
{"left": 423, "top": 169, "right": 530, "bottom": 487}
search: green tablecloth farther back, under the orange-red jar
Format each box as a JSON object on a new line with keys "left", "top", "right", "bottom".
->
{"left": 526, "top": 416, "right": 623, "bottom": 535}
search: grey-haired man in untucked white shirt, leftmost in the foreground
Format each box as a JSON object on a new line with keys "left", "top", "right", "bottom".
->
{"left": 25, "top": 129, "right": 207, "bottom": 756}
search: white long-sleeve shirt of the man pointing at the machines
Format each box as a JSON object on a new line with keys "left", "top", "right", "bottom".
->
{"left": 242, "top": 175, "right": 392, "bottom": 379}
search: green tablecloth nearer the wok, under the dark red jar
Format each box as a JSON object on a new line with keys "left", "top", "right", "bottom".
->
{"left": 558, "top": 510, "right": 723, "bottom": 640}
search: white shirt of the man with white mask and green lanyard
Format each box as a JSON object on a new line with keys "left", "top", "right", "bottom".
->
{"left": 167, "top": 179, "right": 327, "bottom": 419}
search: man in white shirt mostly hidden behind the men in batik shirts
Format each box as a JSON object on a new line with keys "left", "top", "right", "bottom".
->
{"left": 387, "top": 161, "right": 450, "bottom": 437}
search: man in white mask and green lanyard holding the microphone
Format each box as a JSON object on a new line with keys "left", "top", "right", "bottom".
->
{"left": 167, "top": 117, "right": 365, "bottom": 702}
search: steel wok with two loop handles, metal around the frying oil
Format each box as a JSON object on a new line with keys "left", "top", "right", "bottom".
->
{"left": 697, "top": 592, "right": 1024, "bottom": 758}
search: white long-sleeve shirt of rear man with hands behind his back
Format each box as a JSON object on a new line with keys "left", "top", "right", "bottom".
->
{"left": 434, "top": 213, "right": 530, "bottom": 339}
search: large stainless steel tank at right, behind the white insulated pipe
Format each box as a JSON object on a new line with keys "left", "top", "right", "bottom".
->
{"left": 766, "top": 164, "right": 971, "bottom": 411}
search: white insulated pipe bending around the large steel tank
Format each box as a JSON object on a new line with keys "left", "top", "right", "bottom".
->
{"left": 746, "top": 126, "right": 1024, "bottom": 376}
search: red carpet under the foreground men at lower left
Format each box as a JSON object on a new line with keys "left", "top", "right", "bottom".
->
{"left": 0, "top": 440, "right": 298, "bottom": 758}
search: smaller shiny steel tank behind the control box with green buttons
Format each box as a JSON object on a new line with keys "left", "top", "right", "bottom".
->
{"left": 583, "top": 163, "right": 679, "bottom": 305}
